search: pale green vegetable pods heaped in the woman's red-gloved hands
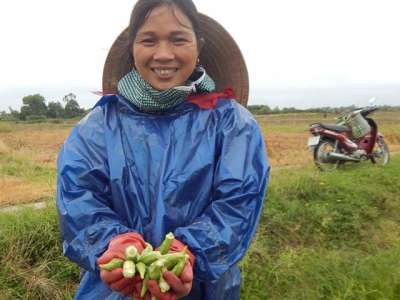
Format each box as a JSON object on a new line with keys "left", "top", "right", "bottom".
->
{"left": 99, "top": 232, "right": 189, "bottom": 299}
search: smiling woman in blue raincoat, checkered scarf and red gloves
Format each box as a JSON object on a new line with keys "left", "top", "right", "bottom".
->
{"left": 57, "top": 0, "right": 269, "bottom": 300}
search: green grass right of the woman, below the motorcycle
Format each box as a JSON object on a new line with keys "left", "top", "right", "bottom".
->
{"left": 241, "top": 155, "right": 400, "bottom": 300}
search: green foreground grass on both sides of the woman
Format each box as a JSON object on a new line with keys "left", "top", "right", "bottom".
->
{"left": 0, "top": 155, "right": 400, "bottom": 300}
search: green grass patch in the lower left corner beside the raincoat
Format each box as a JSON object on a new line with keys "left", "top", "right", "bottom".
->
{"left": 0, "top": 204, "right": 80, "bottom": 300}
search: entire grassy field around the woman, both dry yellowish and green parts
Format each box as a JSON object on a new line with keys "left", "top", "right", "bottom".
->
{"left": 0, "top": 115, "right": 400, "bottom": 300}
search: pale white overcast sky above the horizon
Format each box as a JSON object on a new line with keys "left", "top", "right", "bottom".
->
{"left": 0, "top": 0, "right": 400, "bottom": 112}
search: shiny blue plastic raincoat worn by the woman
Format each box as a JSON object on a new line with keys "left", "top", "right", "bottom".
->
{"left": 57, "top": 95, "right": 269, "bottom": 300}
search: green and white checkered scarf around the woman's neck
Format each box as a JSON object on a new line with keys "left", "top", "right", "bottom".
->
{"left": 118, "top": 67, "right": 215, "bottom": 111}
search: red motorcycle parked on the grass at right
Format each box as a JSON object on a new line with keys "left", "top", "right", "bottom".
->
{"left": 308, "top": 98, "right": 389, "bottom": 171}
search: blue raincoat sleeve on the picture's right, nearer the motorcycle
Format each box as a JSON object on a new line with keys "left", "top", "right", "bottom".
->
{"left": 175, "top": 99, "right": 270, "bottom": 281}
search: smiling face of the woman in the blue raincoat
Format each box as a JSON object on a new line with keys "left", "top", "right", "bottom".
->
{"left": 133, "top": 6, "right": 204, "bottom": 91}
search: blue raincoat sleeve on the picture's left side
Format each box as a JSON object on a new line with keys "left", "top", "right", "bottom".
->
{"left": 56, "top": 107, "right": 132, "bottom": 271}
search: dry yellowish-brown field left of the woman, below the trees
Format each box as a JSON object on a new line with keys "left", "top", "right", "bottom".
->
{"left": 0, "top": 123, "right": 71, "bottom": 206}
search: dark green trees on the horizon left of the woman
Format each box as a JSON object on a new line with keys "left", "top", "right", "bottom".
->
{"left": 0, "top": 93, "right": 89, "bottom": 122}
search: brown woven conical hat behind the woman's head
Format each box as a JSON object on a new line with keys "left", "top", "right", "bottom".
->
{"left": 103, "top": 13, "right": 249, "bottom": 107}
